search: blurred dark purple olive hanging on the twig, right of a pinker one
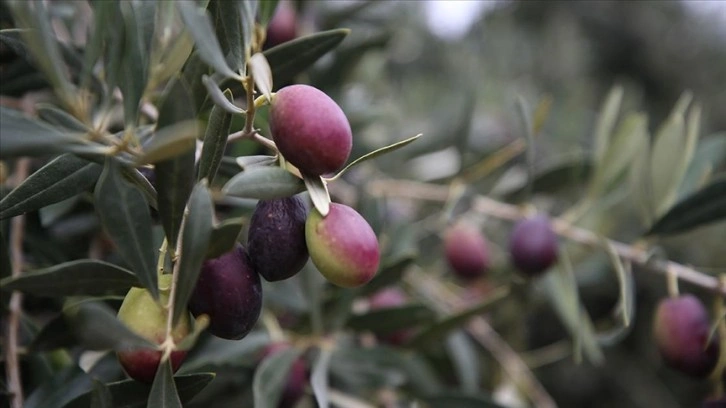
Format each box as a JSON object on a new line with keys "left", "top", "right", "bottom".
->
{"left": 509, "top": 215, "right": 557, "bottom": 276}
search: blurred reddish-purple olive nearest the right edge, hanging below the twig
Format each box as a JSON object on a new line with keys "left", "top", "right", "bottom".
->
{"left": 653, "top": 295, "right": 719, "bottom": 377}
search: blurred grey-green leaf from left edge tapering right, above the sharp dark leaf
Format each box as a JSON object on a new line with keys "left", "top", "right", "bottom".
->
{"left": 0, "top": 106, "right": 98, "bottom": 159}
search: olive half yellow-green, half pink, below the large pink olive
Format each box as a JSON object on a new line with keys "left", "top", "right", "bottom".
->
{"left": 305, "top": 203, "right": 381, "bottom": 288}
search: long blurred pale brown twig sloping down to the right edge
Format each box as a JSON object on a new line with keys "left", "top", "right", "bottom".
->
{"left": 368, "top": 180, "right": 726, "bottom": 295}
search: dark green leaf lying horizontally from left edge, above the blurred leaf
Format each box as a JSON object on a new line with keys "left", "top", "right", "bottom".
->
{"left": 0, "top": 259, "right": 139, "bottom": 296}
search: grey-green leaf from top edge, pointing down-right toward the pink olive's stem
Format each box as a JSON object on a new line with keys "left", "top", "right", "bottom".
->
{"left": 177, "top": 1, "right": 242, "bottom": 80}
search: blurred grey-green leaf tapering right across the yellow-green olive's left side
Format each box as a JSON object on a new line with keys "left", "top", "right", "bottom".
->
{"left": 64, "top": 301, "right": 157, "bottom": 351}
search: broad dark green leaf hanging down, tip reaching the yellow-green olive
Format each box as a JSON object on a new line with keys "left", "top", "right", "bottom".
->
{"left": 94, "top": 158, "right": 159, "bottom": 299}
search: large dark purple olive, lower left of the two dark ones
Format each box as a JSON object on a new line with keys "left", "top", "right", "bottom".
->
{"left": 189, "top": 244, "right": 262, "bottom": 340}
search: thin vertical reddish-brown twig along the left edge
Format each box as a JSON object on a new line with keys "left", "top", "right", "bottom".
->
{"left": 5, "top": 158, "right": 30, "bottom": 408}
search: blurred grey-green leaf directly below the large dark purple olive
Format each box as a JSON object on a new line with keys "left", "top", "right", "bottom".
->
{"left": 180, "top": 331, "right": 270, "bottom": 373}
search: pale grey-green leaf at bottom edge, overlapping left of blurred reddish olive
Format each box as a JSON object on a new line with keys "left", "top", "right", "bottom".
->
{"left": 252, "top": 347, "right": 301, "bottom": 408}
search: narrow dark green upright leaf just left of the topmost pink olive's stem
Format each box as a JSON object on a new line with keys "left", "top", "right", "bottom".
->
{"left": 197, "top": 89, "right": 233, "bottom": 186}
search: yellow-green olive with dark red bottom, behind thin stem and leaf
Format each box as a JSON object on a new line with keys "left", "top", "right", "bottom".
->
{"left": 116, "top": 275, "right": 191, "bottom": 384}
